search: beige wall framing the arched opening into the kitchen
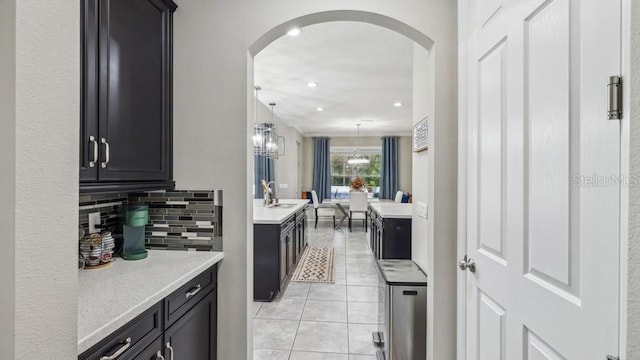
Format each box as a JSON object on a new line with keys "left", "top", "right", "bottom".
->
{"left": 168, "top": 0, "right": 457, "bottom": 359}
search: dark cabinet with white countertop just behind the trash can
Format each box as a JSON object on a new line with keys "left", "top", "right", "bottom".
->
{"left": 369, "top": 202, "right": 413, "bottom": 259}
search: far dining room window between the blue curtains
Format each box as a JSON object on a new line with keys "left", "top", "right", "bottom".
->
{"left": 331, "top": 146, "right": 382, "bottom": 198}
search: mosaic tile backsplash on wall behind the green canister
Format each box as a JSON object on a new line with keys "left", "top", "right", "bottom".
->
{"left": 129, "top": 190, "right": 222, "bottom": 251}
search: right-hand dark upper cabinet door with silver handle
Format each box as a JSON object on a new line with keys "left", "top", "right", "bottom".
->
{"left": 98, "top": 0, "right": 172, "bottom": 181}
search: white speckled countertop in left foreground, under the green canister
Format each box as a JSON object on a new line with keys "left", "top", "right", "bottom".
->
{"left": 78, "top": 250, "right": 224, "bottom": 354}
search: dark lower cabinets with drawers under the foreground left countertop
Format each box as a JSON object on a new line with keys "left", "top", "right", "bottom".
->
{"left": 78, "top": 265, "right": 217, "bottom": 360}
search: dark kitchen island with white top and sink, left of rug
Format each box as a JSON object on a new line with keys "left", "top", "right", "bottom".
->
{"left": 253, "top": 199, "right": 309, "bottom": 301}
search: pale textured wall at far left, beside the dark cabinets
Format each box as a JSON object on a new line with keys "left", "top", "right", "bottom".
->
{"left": 0, "top": 0, "right": 80, "bottom": 359}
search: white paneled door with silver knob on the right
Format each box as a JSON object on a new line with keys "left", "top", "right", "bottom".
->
{"left": 460, "top": 0, "right": 621, "bottom": 360}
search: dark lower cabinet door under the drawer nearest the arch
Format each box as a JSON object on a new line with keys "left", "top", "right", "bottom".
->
{"left": 164, "top": 290, "right": 216, "bottom": 360}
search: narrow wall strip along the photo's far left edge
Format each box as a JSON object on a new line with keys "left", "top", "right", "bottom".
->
{"left": 0, "top": 1, "right": 16, "bottom": 358}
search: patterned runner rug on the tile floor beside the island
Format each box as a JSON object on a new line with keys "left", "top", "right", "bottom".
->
{"left": 291, "top": 246, "right": 333, "bottom": 282}
